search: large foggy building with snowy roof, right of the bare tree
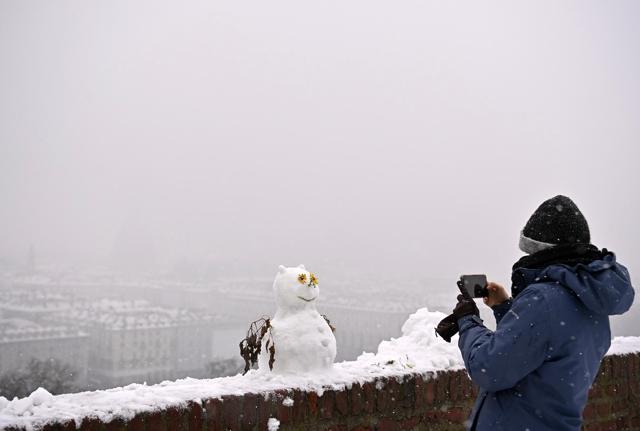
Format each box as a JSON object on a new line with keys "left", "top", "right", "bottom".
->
{"left": 58, "top": 300, "right": 212, "bottom": 388}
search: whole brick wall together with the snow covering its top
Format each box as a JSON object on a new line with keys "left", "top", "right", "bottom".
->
{"left": 0, "top": 309, "right": 640, "bottom": 431}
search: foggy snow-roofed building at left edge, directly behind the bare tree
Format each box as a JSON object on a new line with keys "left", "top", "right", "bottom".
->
{"left": 0, "top": 317, "right": 89, "bottom": 388}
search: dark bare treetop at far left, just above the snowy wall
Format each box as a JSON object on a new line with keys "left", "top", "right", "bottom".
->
{"left": 0, "top": 358, "right": 76, "bottom": 399}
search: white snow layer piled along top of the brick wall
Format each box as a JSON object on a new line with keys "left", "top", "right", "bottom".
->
{"left": 0, "top": 308, "right": 640, "bottom": 430}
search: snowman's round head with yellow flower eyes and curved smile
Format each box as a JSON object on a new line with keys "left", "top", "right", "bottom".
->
{"left": 273, "top": 265, "right": 320, "bottom": 310}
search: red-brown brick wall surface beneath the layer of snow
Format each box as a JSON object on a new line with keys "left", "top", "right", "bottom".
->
{"left": 7, "top": 353, "right": 640, "bottom": 431}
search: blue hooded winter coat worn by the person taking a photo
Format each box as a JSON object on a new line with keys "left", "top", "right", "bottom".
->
{"left": 458, "top": 254, "right": 634, "bottom": 431}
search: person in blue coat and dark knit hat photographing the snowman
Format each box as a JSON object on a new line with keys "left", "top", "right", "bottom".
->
{"left": 453, "top": 196, "right": 634, "bottom": 431}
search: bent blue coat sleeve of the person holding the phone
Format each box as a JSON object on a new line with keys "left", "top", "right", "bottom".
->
{"left": 458, "top": 285, "right": 550, "bottom": 392}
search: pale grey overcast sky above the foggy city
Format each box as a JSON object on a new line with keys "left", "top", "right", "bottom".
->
{"left": 0, "top": 0, "right": 640, "bottom": 281}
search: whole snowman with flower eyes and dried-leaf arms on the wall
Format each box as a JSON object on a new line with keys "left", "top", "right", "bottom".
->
{"left": 240, "top": 265, "right": 336, "bottom": 374}
